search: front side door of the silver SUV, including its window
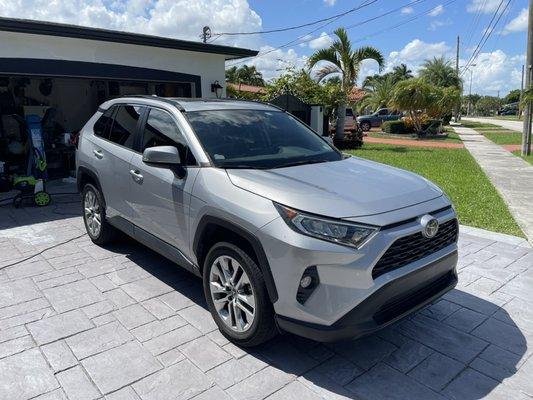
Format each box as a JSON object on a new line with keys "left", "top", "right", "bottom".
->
{"left": 130, "top": 107, "right": 199, "bottom": 254}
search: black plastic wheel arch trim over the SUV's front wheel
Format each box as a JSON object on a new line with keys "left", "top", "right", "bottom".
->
{"left": 193, "top": 215, "right": 278, "bottom": 303}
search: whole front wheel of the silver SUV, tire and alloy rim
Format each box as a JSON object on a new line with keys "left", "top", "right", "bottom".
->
{"left": 203, "top": 242, "right": 276, "bottom": 347}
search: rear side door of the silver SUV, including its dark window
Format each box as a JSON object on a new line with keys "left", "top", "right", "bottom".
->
{"left": 92, "top": 104, "right": 141, "bottom": 219}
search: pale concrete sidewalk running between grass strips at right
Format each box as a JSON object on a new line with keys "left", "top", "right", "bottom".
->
{"left": 452, "top": 125, "right": 533, "bottom": 244}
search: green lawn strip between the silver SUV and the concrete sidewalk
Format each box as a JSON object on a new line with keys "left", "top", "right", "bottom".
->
{"left": 349, "top": 143, "right": 524, "bottom": 237}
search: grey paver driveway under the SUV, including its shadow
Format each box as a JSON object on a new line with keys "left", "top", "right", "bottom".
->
{"left": 0, "top": 199, "right": 533, "bottom": 400}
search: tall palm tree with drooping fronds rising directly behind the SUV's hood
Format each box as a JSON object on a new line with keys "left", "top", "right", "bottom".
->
{"left": 308, "top": 28, "right": 384, "bottom": 140}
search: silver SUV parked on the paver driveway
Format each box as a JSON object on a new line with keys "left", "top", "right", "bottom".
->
{"left": 77, "top": 96, "right": 458, "bottom": 346}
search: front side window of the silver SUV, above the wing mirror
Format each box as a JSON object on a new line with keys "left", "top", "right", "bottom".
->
{"left": 141, "top": 108, "right": 196, "bottom": 165}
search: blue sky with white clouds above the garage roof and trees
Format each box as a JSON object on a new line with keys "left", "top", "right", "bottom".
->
{"left": 0, "top": 0, "right": 527, "bottom": 96}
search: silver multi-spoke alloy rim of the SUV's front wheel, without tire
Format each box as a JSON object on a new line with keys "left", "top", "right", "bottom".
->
{"left": 209, "top": 255, "right": 256, "bottom": 333}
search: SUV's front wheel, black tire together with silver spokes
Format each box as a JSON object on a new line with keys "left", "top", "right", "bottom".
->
{"left": 203, "top": 242, "right": 277, "bottom": 347}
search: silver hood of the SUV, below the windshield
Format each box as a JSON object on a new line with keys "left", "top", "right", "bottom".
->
{"left": 227, "top": 157, "right": 442, "bottom": 218}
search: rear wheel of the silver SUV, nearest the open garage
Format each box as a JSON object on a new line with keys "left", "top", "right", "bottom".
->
{"left": 81, "top": 183, "right": 117, "bottom": 246}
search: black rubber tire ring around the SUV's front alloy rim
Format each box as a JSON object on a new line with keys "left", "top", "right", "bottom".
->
{"left": 203, "top": 242, "right": 274, "bottom": 346}
